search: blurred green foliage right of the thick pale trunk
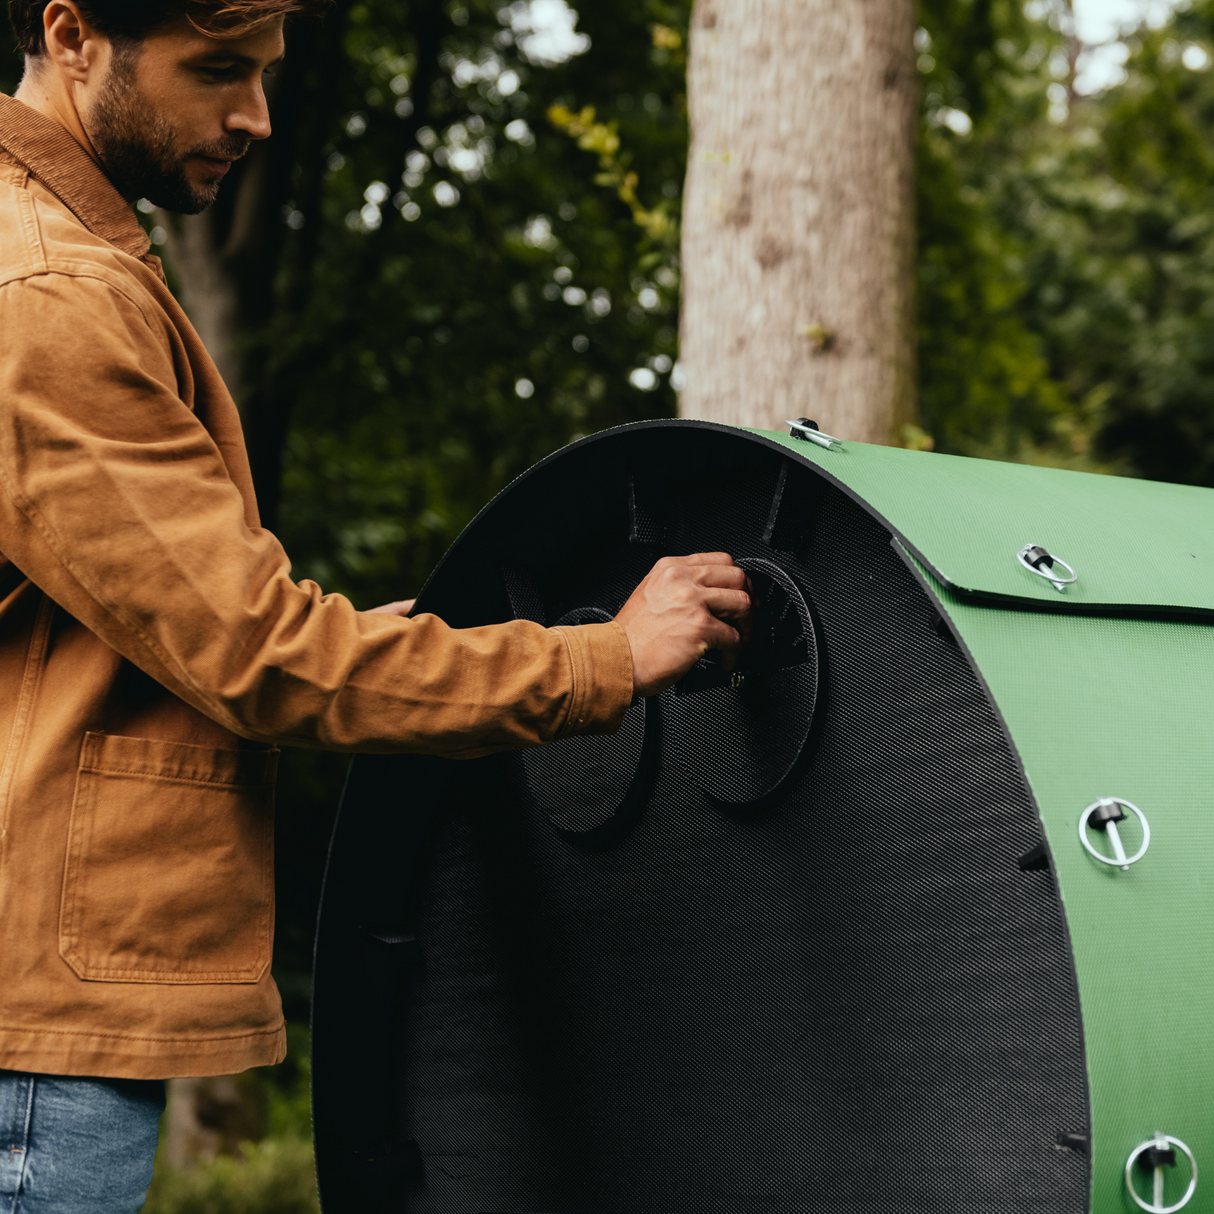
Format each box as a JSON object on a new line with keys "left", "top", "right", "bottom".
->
{"left": 919, "top": 0, "right": 1214, "bottom": 484}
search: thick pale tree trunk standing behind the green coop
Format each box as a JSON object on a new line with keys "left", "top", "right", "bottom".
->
{"left": 681, "top": 0, "right": 915, "bottom": 444}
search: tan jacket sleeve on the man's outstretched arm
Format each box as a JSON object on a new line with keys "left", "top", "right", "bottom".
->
{"left": 0, "top": 273, "right": 632, "bottom": 755}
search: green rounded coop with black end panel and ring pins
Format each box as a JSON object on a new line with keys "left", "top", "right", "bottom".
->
{"left": 313, "top": 422, "right": 1214, "bottom": 1214}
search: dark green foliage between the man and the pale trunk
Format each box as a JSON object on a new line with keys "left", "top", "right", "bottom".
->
{"left": 275, "top": 0, "right": 687, "bottom": 606}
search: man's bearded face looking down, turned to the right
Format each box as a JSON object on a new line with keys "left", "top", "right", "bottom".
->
{"left": 81, "top": 17, "right": 283, "bottom": 215}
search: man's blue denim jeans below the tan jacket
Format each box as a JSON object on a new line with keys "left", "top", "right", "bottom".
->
{"left": 0, "top": 1071, "right": 164, "bottom": 1214}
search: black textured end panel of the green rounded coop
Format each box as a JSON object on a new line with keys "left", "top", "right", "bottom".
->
{"left": 314, "top": 426, "right": 1088, "bottom": 1214}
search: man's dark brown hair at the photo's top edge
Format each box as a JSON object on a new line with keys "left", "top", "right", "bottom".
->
{"left": 8, "top": 0, "right": 329, "bottom": 56}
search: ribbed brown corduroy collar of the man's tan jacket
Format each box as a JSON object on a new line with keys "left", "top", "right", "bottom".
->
{"left": 0, "top": 93, "right": 152, "bottom": 257}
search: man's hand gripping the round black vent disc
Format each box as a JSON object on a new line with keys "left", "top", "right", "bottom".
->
{"left": 615, "top": 552, "right": 753, "bottom": 696}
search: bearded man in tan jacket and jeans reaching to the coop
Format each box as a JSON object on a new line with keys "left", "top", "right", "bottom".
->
{"left": 0, "top": 0, "right": 750, "bottom": 1214}
